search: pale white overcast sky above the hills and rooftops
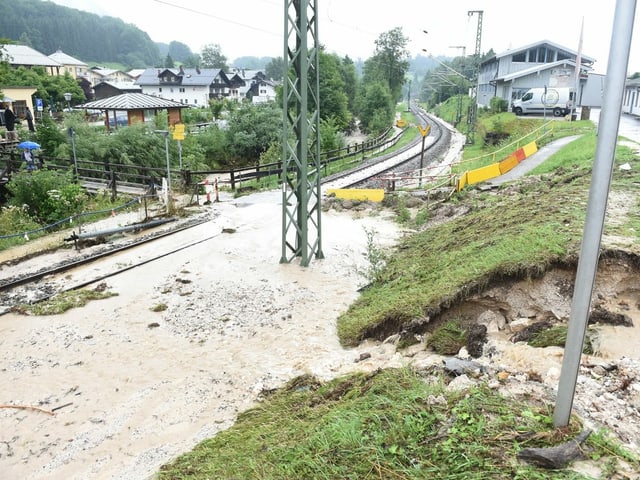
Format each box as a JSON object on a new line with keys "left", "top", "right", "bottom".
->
{"left": 47, "top": 0, "right": 640, "bottom": 73}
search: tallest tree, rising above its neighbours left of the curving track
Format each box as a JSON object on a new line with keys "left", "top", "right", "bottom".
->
{"left": 363, "top": 27, "right": 409, "bottom": 101}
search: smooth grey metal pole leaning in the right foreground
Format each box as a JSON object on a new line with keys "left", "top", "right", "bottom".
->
{"left": 553, "top": 0, "right": 636, "bottom": 427}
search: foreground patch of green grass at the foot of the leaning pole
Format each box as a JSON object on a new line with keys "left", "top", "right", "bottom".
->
{"left": 158, "top": 368, "right": 637, "bottom": 480}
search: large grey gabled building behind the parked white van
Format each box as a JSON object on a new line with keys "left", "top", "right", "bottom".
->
{"left": 477, "top": 40, "right": 595, "bottom": 106}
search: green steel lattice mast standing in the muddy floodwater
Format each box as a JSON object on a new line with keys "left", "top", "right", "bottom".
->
{"left": 280, "top": 0, "right": 324, "bottom": 267}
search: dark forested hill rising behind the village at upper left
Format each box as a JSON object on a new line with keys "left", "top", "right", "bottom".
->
{"left": 0, "top": 0, "right": 161, "bottom": 68}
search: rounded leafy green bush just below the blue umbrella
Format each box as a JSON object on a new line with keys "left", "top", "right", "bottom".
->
{"left": 7, "top": 170, "right": 88, "bottom": 224}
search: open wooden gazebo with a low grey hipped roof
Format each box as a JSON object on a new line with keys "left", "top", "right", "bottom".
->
{"left": 75, "top": 93, "right": 189, "bottom": 130}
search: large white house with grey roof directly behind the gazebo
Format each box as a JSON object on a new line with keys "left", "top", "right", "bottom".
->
{"left": 135, "top": 67, "right": 232, "bottom": 107}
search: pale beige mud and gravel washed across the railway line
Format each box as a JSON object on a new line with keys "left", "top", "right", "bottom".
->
{"left": 0, "top": 193, "right": 640, "bottom": 480}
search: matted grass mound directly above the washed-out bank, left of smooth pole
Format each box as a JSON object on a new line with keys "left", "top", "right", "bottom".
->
{"left": 338, "top": 178, "right": 586, "bottom": 346}
